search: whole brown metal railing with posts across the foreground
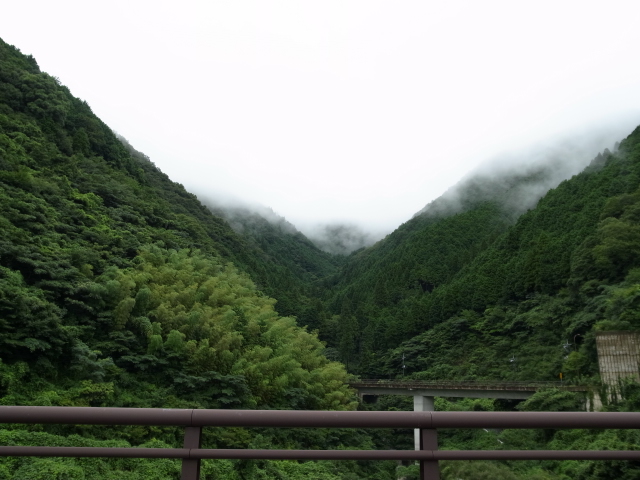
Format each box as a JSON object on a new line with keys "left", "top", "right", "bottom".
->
{"left": 0, "top": 406, "right": 640, "bottom": 480}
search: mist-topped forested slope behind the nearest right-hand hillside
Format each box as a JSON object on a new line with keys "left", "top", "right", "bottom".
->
{"left": 321, "top": 151, "right": 600, "bottom": 368}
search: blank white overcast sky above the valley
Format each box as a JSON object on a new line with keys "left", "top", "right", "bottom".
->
{"left": 0, "top": 0, "right": 640, "bottom": 235}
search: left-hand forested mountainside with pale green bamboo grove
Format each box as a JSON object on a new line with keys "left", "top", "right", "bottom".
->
{"left": 0, "top": 41, "right": 383, "bottom": 479}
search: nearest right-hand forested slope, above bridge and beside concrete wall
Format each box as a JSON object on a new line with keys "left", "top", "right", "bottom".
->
{"left": 380, "top": 129, "right": 640, "bottom": 380}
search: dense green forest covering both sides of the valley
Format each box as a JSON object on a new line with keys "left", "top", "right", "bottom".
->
{"left": 0, "top": 40, "right": 640, "bottom": 480}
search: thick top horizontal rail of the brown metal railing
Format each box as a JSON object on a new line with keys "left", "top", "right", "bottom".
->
{"left": 0, "top": 406, "right": 640, "bottom": 428}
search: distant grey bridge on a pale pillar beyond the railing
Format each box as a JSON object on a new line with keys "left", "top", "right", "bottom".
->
{"left": 349, "top": 379, "right": 588, "bottom": 450}
